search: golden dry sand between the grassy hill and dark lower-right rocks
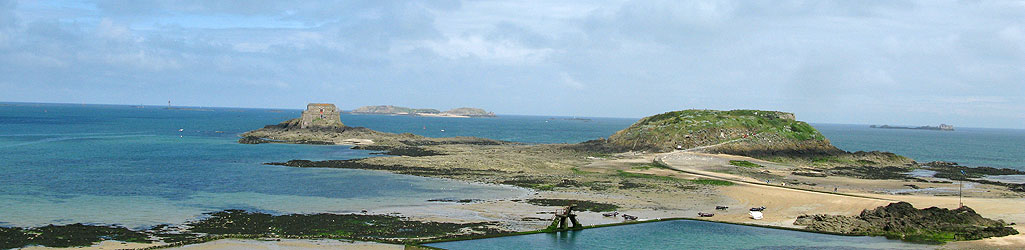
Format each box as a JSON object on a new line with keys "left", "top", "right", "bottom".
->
{"left": 654, "top": 151, "right": 1025, "bottom": 249}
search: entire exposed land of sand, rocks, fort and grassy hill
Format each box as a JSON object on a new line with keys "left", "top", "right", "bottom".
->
{"left": 8, "top": 103, "right": 1025, "bottom": 248}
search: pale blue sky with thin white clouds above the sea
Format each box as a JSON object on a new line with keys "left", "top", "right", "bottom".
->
{"left": 0, "top": 0, "right": 1025, "bottom": 128}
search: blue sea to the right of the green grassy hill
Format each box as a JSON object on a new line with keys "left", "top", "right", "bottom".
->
{"left": 813, "top": 124, "right": 1025, "bottom": 170}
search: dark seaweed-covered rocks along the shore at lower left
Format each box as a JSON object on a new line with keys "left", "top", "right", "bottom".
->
{"left": 0, "top": 210, "right": 509, "bottom": 249}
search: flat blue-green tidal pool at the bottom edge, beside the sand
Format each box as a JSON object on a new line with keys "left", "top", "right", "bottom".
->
{"left": 427, "top": 220, "right": 935, "bottom": 250}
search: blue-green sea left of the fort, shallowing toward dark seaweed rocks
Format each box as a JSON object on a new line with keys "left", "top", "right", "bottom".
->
{"left": 0, "top": 105, "right": 569, "bottom": 227}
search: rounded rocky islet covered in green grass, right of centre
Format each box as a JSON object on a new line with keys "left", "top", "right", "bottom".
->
{"left": 608, "top": 110, "right": 913, "bottom": 166}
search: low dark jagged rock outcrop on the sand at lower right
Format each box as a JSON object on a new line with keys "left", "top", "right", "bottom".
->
{"left": 793, "top": 202, "right": 1018, "bottom": 242}
